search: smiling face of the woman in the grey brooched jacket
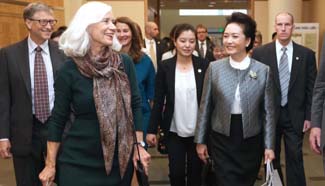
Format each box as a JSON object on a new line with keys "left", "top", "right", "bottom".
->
{"left": 223, "top": 23, "right": 250, "bottom": 61}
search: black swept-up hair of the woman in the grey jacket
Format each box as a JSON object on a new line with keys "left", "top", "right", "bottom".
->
{"left": 225, "top": 12, "right": 256, "bottom": 52}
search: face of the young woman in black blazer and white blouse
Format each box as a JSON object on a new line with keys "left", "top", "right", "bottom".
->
{"left": 174, "top": 30, "right": 196, "bottom": 57}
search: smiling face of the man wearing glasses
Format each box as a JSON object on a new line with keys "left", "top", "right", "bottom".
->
{"left": 25, "top": 11, "right": 54, "bottom": 45}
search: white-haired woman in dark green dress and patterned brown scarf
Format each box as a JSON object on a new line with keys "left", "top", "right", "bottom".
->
{"left": 39, "top": 2, "right": 150, "bottom": 186}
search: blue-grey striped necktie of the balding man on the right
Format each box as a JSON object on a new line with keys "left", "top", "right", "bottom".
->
{"left": 279, "top": 47, "right": 290, "bottom": 106}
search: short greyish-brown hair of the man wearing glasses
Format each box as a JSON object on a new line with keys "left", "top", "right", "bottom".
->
{"left": 23, "top": 2, "right": 53, "bottom": 20}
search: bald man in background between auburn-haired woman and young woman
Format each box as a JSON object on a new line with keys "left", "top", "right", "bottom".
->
{"left": 144, "top": 21, "right": 162, "bottom": 72}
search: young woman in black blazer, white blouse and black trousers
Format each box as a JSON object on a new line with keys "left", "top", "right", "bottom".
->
{"left": 147, "top": 24, "right": 208, "bottom": 186}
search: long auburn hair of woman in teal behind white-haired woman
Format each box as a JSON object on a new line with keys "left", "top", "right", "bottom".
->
{"left": 116, "top": 17, "right": 144, "bottom": 63}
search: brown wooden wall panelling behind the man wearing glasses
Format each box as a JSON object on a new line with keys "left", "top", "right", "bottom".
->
{"left": 0, "top": 0, "right": 65, "bottom": 48}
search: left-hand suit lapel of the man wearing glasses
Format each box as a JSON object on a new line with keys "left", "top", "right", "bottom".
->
{"left": 17, "top": 38, "right": 32, "bottom": 98}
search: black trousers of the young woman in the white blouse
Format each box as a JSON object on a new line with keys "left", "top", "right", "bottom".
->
{"left": 167, "top": 132, "right": 202, "bottom": 186}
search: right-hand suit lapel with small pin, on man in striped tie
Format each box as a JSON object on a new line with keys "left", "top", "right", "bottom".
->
{"left": 288, "top": 42, "right": 302, "bottom": 91}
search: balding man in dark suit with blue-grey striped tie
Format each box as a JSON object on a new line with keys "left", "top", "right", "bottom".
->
{"left": 252, "top": 13, "right": 317, "bottom": 186}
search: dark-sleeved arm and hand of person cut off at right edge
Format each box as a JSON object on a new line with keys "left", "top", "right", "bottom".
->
{"left": 309, "top": 35, "right": 325, "bottom": 172}
